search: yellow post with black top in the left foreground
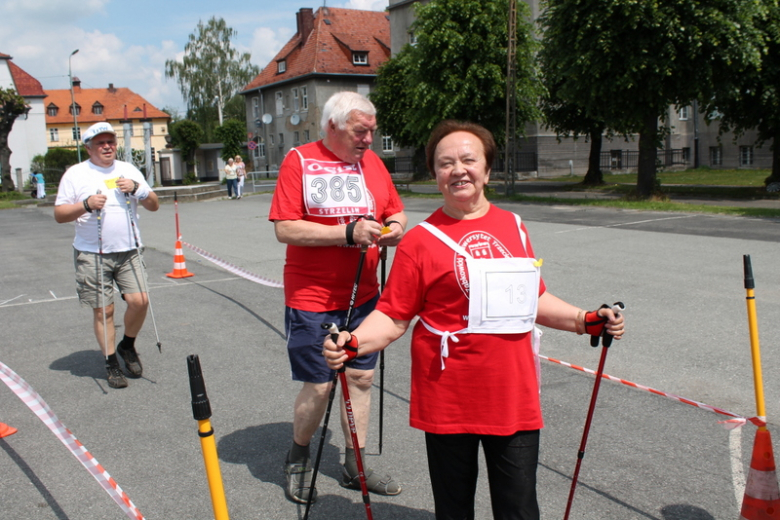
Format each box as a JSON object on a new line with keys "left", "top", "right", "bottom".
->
{"left": 187, "top": 355, "right": 230, "bottom": 520}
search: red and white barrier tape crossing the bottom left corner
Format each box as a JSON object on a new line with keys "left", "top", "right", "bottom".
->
{"left": 0, "top": 362, "right": 144, "bottom": 520}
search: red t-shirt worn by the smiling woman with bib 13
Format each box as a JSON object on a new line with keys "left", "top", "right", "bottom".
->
{"left": 376, "top": 206, "right": 545, "bottom": 435}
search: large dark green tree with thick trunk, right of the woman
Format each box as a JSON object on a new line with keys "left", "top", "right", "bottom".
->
{"left": 540, "top": 0, "right": 761, "bottom": 197}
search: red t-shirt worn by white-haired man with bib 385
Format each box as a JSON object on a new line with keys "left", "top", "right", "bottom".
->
{"left": 268, "top": 141, "right": 403, "bottom": 312}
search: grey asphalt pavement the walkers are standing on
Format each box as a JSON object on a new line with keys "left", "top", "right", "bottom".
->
{"left": 0, "top": 194, "right": 780, "bottom": 520}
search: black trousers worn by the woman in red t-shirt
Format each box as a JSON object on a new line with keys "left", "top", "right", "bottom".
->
{"left": 425, "top": 430, "right": 539, "bottom": 520}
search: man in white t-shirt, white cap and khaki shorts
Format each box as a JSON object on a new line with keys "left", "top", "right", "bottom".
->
{"left": 54, "top": 123, "right": 160, "bottom": 388}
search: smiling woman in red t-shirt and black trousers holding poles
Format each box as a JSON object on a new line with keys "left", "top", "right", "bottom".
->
{"left": 323, "top": 121, "right": 623, "bottom": 520}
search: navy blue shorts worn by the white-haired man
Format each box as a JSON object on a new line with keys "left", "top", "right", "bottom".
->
{"left": 284, "top": 294, "right": 379, "bottom": 383}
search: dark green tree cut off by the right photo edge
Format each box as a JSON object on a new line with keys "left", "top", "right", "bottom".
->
{"left": 708, "top": 1, "right": 780, "bottom": 184}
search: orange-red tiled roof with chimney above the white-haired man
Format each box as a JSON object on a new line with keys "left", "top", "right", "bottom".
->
{"left": 244, "top": 7, "right": 390, "bottom": 92}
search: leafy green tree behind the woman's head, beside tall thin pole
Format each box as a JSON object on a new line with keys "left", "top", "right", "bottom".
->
{"left": 371, "top": 0, "right": 540, "bottom": 177}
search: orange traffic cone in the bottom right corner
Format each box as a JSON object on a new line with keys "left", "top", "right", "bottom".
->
{"left": 739, "top": 428, "right": 780, "bottom": 520}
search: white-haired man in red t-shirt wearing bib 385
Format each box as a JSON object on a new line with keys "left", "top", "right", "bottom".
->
{"left": 268, "top": 92, "right": 407, "bottom": 503}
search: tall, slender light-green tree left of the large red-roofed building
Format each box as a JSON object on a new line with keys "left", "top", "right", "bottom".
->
{"left": 165, "top": 17, "right": 260, "bottom": 141}
